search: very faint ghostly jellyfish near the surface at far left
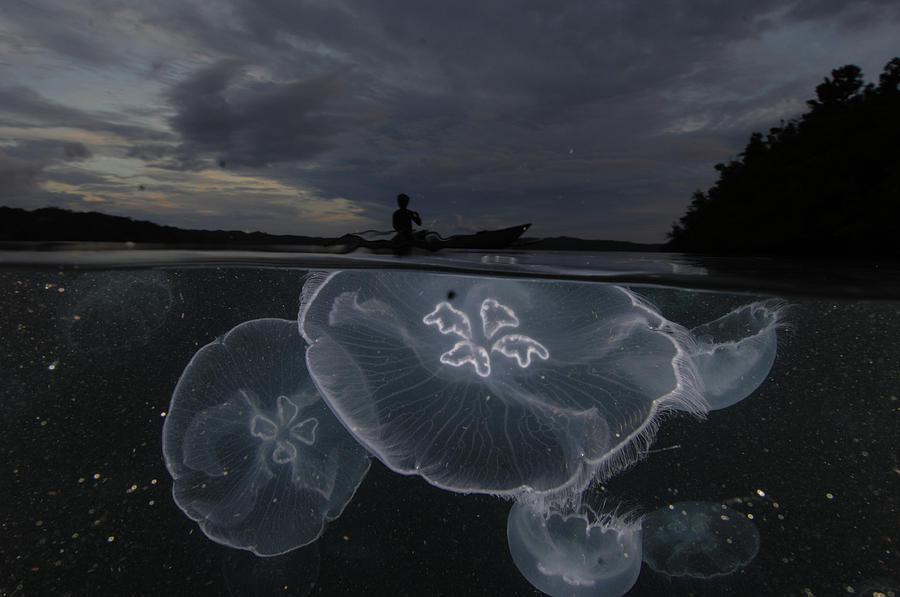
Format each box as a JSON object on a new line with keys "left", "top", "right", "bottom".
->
{"left": 59, "top": 270, "right": 172, "bottom": 353}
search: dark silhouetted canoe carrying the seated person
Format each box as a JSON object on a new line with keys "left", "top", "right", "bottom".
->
{"left": 341, "top": 224, "right": 531, "bottom": 252}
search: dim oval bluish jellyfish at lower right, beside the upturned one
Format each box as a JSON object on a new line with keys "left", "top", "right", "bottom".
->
{"left": 643, "top": 502, "right": 759, "bottom": 578}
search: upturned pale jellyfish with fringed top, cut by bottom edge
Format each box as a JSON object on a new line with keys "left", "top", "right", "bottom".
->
{"left": 506, "top": 502, "right": 641, "bottom": 597}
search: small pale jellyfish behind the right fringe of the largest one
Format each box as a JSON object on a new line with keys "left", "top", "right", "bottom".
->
{"left": 691, "top": 301, "right": 784, "bottom": 410}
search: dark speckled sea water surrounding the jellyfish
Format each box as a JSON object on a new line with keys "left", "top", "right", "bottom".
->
{"left": 0, "top": 252, "right": 900, "bottom": 596}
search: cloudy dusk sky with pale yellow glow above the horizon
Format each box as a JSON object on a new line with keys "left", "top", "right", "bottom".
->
{"left": 0, "top": 0, "right": 900, "bottom": 243}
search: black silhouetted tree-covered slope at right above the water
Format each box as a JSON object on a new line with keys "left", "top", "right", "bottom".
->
{"left": 669, "top": 57, "right": 900, "bottom": 257}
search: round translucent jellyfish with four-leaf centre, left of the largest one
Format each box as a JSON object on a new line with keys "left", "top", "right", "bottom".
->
{"left": 163, "top": 319, "right": 369, "bottom": 556}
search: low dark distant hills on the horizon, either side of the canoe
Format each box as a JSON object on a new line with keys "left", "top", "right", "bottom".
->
{"left": 0, "top": 207, "right": 662, "bottom": 252}
